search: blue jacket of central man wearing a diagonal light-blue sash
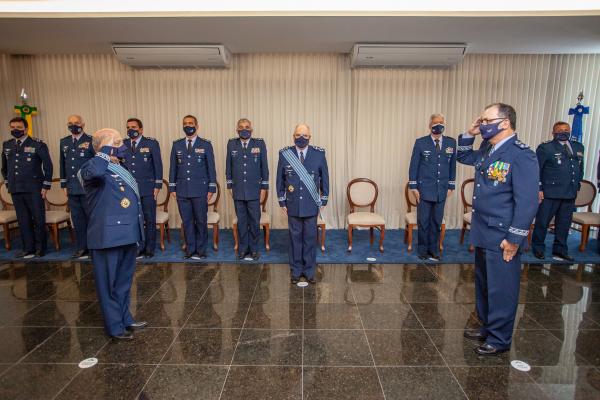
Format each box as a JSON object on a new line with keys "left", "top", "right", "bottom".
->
{"left": 277, "top": 146, "right": 329, "bottom": 217}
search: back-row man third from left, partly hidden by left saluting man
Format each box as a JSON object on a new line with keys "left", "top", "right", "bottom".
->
{"left": 124, "top": 118, "right": 162, "bottom": 258}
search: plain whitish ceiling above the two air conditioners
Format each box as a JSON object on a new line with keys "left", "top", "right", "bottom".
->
{"left": 0, "top": 16, "right": 600, "bottom": 54}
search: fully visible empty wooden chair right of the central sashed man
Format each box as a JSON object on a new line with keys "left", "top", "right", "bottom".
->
{"left": 346, "top": 178, "right": 385, "bottom": 253}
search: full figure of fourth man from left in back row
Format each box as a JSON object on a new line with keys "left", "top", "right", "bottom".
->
{"left": 169, "top": 115, "right": 217, "bottom": 260}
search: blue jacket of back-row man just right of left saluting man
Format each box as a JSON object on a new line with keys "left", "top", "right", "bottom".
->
{"left": 123, "top": 135, "right": 162, "bottom": 197}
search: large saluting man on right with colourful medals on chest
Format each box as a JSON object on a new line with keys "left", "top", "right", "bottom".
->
{"left": 458, "top": 103, "right": 539, "bottom": 356}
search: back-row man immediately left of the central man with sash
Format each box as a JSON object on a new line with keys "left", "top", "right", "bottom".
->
{"left": 225, "top": 118, "right": 269, "bottom": 261}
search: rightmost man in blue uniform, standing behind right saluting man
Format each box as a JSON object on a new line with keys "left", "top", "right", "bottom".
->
{"left": 532, "top": 121, "right": 584, "bottom": 261}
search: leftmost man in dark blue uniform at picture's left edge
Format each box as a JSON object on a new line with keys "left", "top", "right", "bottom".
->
{"left": 2, "top": 117, "right": 52, "bottom": 258}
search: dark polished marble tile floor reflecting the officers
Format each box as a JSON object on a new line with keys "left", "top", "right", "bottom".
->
{"left": 0, "top": 262, "right": 600, "bottom": 400}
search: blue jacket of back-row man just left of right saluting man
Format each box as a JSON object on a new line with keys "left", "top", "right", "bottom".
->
{"left": 408, "top": 135, "right": 456, "bottom": 202}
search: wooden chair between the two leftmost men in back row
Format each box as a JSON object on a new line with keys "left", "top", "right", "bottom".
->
{"left": 46, "top": 178, "right": 75, "bottom": 251}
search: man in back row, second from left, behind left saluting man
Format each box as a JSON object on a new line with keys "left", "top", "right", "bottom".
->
{"left": 60, "top": 115, "right": 96, "bottom": 259}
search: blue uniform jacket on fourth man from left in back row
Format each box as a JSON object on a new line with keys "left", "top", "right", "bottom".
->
{"left": 169, "top": 137, "right": 217, "bottom": 197}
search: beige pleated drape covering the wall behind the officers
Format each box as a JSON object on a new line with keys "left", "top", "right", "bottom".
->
{"left": 0, "top": 54, "right": 600, "bottom": 228}
